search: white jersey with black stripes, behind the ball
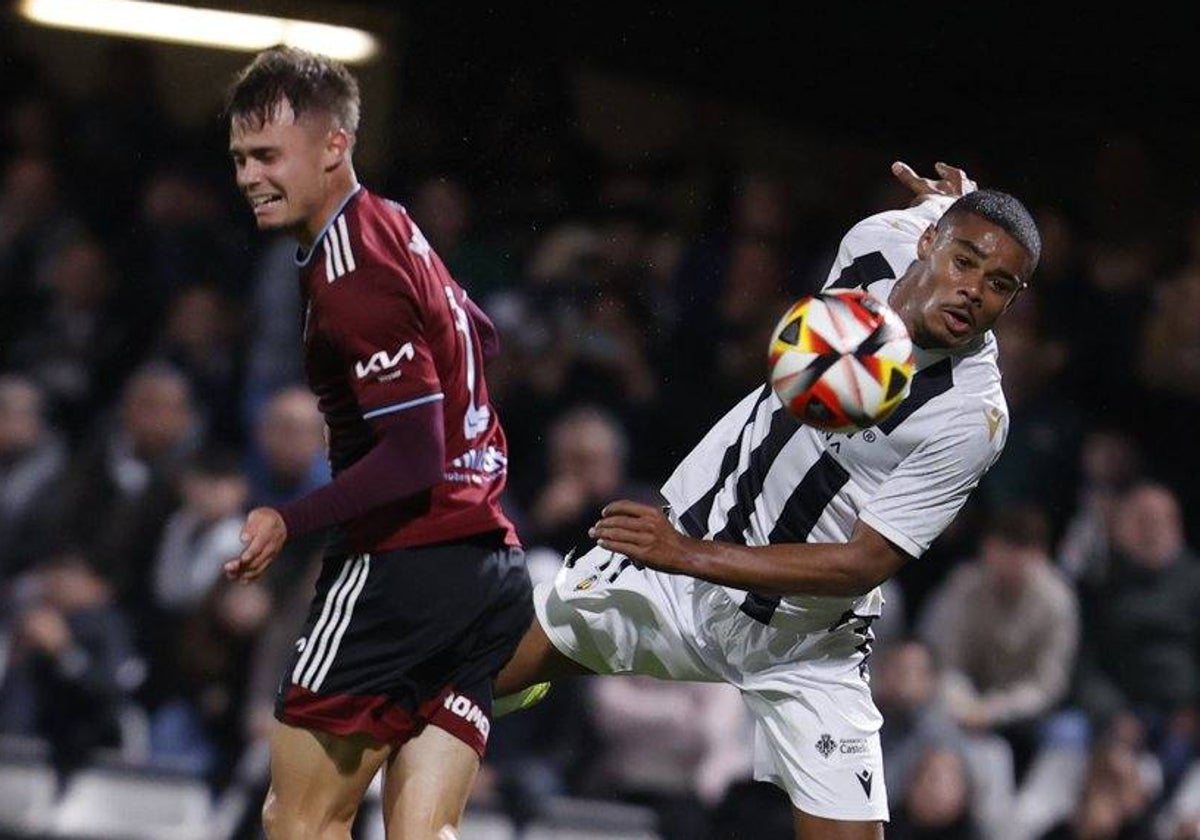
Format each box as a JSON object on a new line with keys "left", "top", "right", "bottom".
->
{"left": 662, "top": 199, "right": 1008, "bottom": 620}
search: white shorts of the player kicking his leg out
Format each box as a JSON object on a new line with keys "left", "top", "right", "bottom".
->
{"left": 534, "top": 547, "right": 888, "bottom": 821}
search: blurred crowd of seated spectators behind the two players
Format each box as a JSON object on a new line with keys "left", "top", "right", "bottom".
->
{"left": 0, "top": 37, "right": 1200, "bottom": 840}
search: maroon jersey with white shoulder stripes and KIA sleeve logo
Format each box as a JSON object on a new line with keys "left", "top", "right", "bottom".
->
{"left": 296, "top": 187, "right": 518, "bottom": 552}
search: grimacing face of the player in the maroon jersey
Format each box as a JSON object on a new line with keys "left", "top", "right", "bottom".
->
{"left": 229, "top": 100, "right": 340, "bottom": 240}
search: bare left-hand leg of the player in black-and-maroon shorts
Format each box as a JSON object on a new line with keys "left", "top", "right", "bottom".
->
{"left": 263, "top": 724, "right": 391, "bottom": 840}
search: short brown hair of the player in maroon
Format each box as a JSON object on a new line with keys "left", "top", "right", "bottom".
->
{"left": 226, "top": 47, "right": 359, "bottom": 134}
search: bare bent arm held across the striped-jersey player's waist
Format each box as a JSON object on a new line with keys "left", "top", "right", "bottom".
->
{"left": 588, "top": 500, "right": 908, "bottom": 596}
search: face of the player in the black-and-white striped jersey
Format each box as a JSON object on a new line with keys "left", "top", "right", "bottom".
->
{"left": 896, "top": 214, "right": 1032, "bottom": 349}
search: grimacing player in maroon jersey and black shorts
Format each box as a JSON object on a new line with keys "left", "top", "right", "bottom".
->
{"left": 226, "top": 48, "right": 533, "bottom": 839}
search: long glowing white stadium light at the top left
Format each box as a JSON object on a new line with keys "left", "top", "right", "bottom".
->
{"left": 18, "top": 0, "right": 379, "bottom": 64}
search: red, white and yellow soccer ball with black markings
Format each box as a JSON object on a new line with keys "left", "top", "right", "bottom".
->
{"left": 768, "top": 289, "right": 914, "bottom": 432}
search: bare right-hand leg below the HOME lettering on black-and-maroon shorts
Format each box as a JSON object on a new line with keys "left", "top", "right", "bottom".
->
{"left": 383, "top": 726, "right": 479, "bottom": 840}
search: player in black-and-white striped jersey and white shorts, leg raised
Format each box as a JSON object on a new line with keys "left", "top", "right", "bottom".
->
{"left": 497, "top": 164, "right": 1040, "bottom": 840}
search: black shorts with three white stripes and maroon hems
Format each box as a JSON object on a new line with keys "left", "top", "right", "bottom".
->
{"left": 275, "top": 534, "right": 533, "bottom": 757}
